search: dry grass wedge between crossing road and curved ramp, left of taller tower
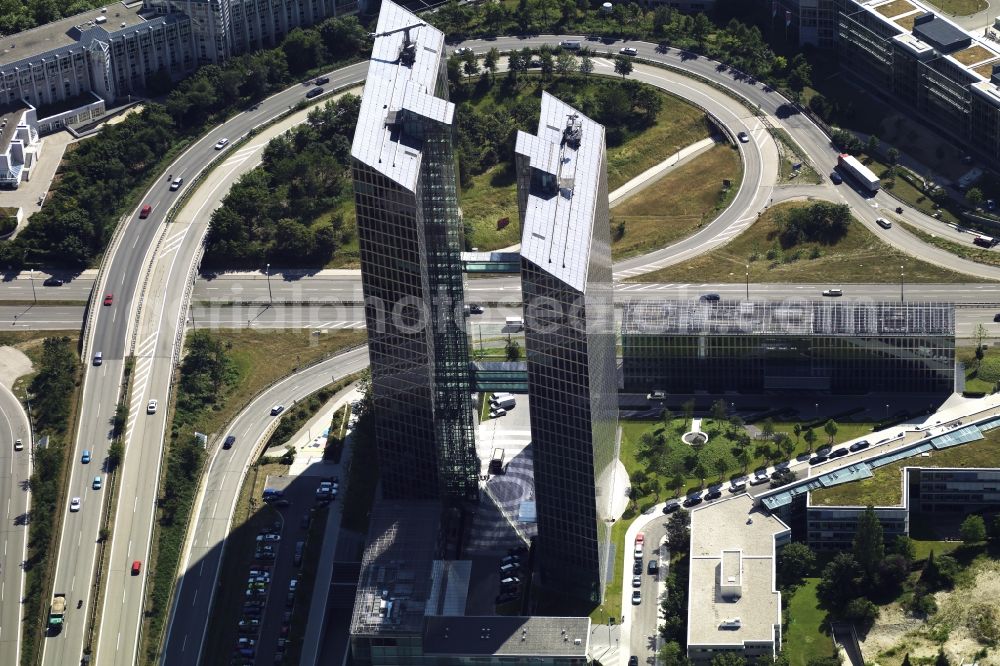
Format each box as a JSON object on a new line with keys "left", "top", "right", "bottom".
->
{"left": 176, "top": 329, "right": 367, "bottom": 436}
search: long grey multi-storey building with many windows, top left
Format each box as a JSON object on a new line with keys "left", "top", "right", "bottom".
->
{"left": 0, "top": 0, "right": 357, "bottom": 133}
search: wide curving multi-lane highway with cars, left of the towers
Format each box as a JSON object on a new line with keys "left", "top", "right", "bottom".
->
{"left": 43, "top": 63, "right": 366, "bottom": 666}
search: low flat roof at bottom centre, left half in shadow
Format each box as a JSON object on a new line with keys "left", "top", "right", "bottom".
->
{"left": 424, "top": 616, "right": 590, "bottom": 659}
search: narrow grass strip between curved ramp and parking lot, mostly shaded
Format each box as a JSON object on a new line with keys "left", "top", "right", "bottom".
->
{"left": 205, "top": 464, "right": 291, "bottom": 664}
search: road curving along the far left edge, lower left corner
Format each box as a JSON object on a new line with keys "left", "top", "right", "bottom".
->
{"left": 0, "top": 384, "right": 33, "bottom": 664}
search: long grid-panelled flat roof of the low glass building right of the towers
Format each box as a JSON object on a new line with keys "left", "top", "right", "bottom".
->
{"left": 621, "top": 299, "right": 955, "bottom": 337}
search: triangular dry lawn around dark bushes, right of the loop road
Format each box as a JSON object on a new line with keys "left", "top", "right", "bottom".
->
{"left": 633, "top": 201, "right": 980, "bottom": 286}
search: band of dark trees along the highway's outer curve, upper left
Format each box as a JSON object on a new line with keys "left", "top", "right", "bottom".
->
{"left": 0, "top": 16, "right": 367, "bottom": 269}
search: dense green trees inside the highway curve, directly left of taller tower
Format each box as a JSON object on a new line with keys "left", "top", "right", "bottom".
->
{"left": 203, "top": 95, "right": 361, "bottom": 268}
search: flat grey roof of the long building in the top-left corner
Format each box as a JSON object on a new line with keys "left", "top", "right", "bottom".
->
{"left": 0, "top": 2, "right": 146, "bottom": 66}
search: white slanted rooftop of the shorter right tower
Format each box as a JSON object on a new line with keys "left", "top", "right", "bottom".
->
{"left": 516, "top": 92, "right": 604, "bottom": 292}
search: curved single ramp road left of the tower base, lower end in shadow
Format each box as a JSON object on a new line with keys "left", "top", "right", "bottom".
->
{"left": 162, "top": 347, "right": 368, "bottom": 665}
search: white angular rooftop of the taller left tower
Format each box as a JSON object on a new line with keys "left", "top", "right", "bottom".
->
{"left": 351, "top": 0, "right": 455, "bottom": 191}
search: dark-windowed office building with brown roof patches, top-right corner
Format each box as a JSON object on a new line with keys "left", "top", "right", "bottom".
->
{"left": 836, "top": 0, "right": 1000, "bottom": 166}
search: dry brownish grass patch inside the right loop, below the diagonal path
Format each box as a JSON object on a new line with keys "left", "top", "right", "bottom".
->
{"left": 611, "top": 144, "right": 743, "bottom": 259}
